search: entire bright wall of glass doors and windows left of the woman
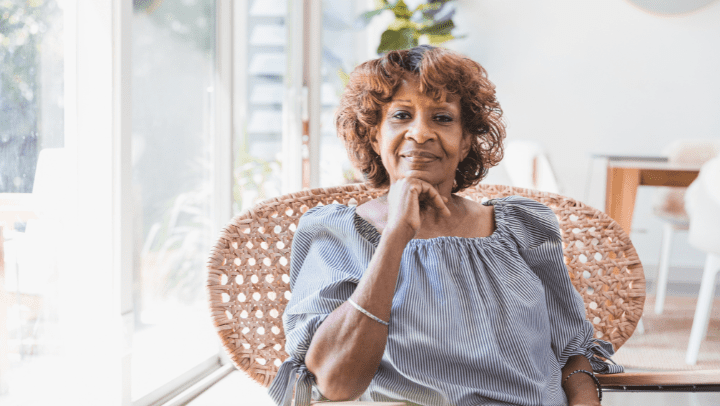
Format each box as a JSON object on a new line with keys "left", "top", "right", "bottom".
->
{"left": 0, "top": 0, "right": 372, "bottom": 406}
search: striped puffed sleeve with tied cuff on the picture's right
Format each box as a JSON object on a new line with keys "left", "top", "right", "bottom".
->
{"left": 493, "top": 196, "right": 623, "bottom": 373}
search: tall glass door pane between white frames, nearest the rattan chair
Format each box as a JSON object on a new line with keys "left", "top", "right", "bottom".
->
{"left": 131, "top": 0, "right": 222, "bottom": 405}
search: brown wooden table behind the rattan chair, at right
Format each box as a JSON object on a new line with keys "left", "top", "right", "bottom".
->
{"left": 605, "top": 156, "right": 700, "bottom": 234}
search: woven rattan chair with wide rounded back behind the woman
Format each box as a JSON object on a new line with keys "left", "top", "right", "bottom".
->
{"left": 207, "top": 184, "right": 720, "bottom": 402}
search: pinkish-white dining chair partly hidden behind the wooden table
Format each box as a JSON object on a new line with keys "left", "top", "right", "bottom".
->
{"left": 653, "top": 139, "right": 720, "bottom": 314}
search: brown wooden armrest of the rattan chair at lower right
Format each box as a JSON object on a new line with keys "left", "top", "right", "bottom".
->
{"left": 596, "top": 370, "right": 720, "bottom": 392}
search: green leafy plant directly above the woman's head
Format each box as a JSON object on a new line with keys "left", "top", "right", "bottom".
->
{"left": 360, "top": 0, "right": 464, "bottom": 54}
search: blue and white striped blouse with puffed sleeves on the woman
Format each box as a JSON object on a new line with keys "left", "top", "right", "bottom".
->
{"left": 270, "top": 196, "right": 622, "bottom": 406}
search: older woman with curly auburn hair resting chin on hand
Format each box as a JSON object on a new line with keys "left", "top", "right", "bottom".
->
{"left": 270, "top": 46, "right": 621, "bottom": 406}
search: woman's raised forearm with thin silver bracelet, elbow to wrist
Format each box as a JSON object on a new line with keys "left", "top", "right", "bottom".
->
{"left": 305, "top": 225, "right": 414, "bottom": 400}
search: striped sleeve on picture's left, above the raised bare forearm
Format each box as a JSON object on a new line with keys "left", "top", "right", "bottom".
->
{"left": 269, "top": 205, "right": 369, "bottom": 406}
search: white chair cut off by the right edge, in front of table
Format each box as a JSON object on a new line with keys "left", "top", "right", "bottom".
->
{"left": 685, "top": 157, "right": 720, "bottom": 365}
